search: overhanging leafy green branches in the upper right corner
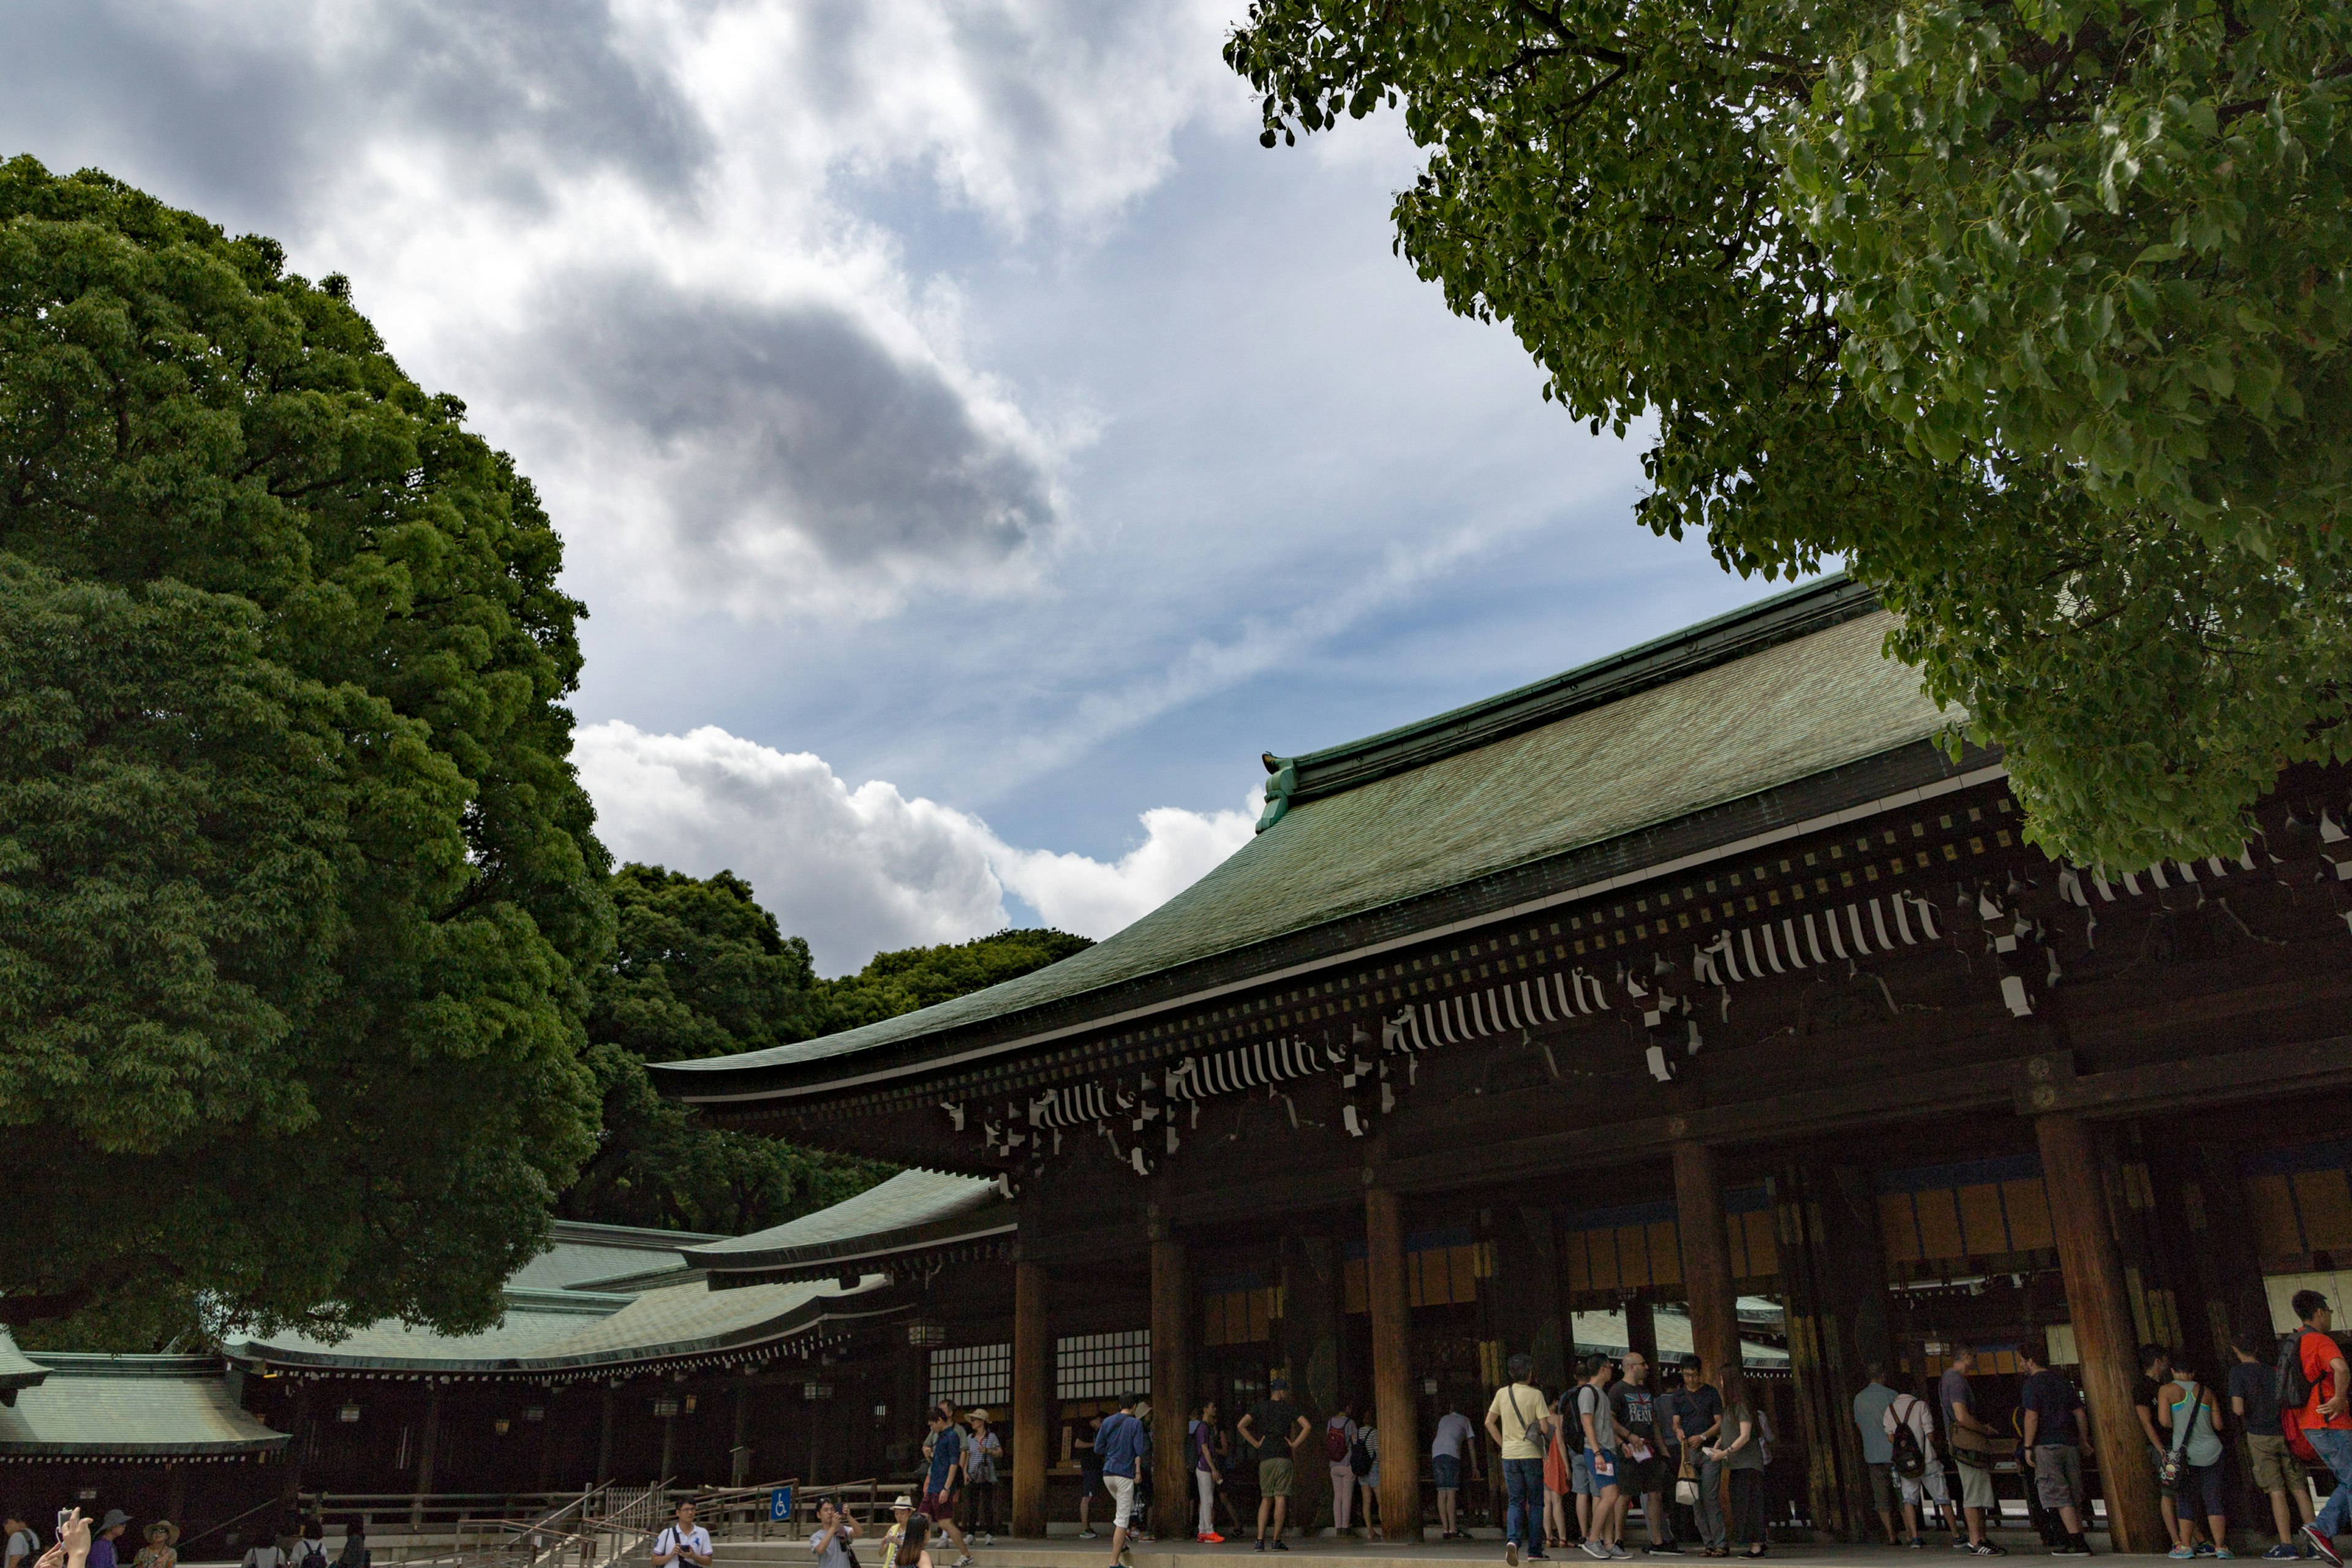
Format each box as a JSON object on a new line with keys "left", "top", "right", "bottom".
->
{"left": 1227, "top": 0, "right": 2352, "bottom": 867}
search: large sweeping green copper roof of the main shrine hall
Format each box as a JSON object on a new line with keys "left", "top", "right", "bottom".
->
{"left": 652, "top": 578, "right": 1952, "bottom": 1100}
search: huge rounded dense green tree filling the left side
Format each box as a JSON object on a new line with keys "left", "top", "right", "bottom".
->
{"left": 0, "top": 157, "right": 611, "bottom": 1343}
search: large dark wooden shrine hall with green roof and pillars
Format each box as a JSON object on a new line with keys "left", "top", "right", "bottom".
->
{"left": 654, "top": 578, "right": 2352, "bottom": 1549}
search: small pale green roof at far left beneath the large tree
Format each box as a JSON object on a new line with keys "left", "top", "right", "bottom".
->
{"left": 0, "top": 1352, "right": 287, "bottom": 1462}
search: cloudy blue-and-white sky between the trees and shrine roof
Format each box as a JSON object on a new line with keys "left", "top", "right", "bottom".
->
{"left": 0, "top": 0, "right": 1796, "bottom": 973}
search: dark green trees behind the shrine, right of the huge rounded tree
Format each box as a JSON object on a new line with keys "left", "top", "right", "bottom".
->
{"left": 560, "top": 865, "right": 1089, "bottom": 1234}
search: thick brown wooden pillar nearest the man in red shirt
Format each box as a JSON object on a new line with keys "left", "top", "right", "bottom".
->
{"left": 2035, "top": 1112, "right": 2168, "bottom": 1551}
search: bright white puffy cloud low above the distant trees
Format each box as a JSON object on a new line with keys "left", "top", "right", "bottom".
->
{"left": 574, "top": 719, "right": 1254, "bottom": 973}
